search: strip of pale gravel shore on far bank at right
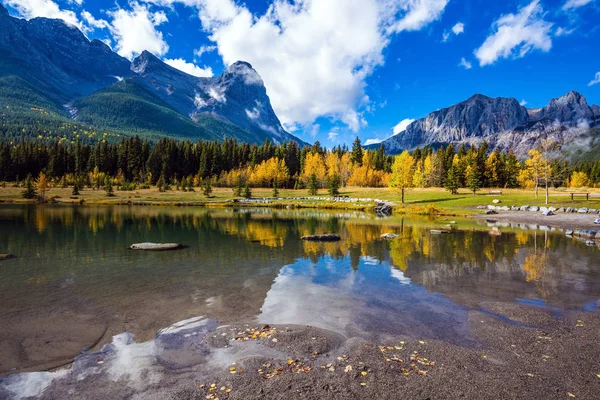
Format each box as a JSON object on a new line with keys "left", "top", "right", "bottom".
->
{"left": 475, "top": 211, "right": 600, "bottom": 231}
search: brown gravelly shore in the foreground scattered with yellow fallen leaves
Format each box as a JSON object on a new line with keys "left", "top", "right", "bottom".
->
{"left": 0, "top": 303, "right": 600, "bottom": 400}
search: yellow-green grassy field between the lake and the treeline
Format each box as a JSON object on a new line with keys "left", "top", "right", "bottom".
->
{"left": 0, "top": 185, "right": 600, "bottom": 213}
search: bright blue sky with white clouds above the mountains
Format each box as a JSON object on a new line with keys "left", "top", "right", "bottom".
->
{"left": 0, "top": 0, "right": 600, "bottom": 147}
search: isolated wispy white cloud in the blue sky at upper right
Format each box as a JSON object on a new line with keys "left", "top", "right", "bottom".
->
{"left": 475, "top": 0, "right": 552, "bottom": 66}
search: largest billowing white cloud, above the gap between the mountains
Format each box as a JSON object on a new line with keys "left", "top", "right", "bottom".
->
{"left": 146, "top": 0, "right": 448, "bottom": 131}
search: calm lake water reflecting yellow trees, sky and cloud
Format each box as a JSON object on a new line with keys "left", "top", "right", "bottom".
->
{"left": 0, "top": 205, "right": 600, "bottom": 375}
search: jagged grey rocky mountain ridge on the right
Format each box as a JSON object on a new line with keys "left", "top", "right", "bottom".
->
{"left": 372, "top": 91, "right": 600, "bottom": 156}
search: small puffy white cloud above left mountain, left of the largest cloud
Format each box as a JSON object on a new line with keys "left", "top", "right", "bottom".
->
{"left": 108, "top": 2, "right": 169, "bottom": 59}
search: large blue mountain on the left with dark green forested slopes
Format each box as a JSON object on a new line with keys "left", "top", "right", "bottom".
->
{"left": 0, "top": 4, "right": 304, "bottom": 145}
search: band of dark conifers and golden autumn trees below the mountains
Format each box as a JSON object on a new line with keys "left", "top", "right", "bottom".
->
{"left": 0, "top": 137, "right": 600, "bottom": 191}
